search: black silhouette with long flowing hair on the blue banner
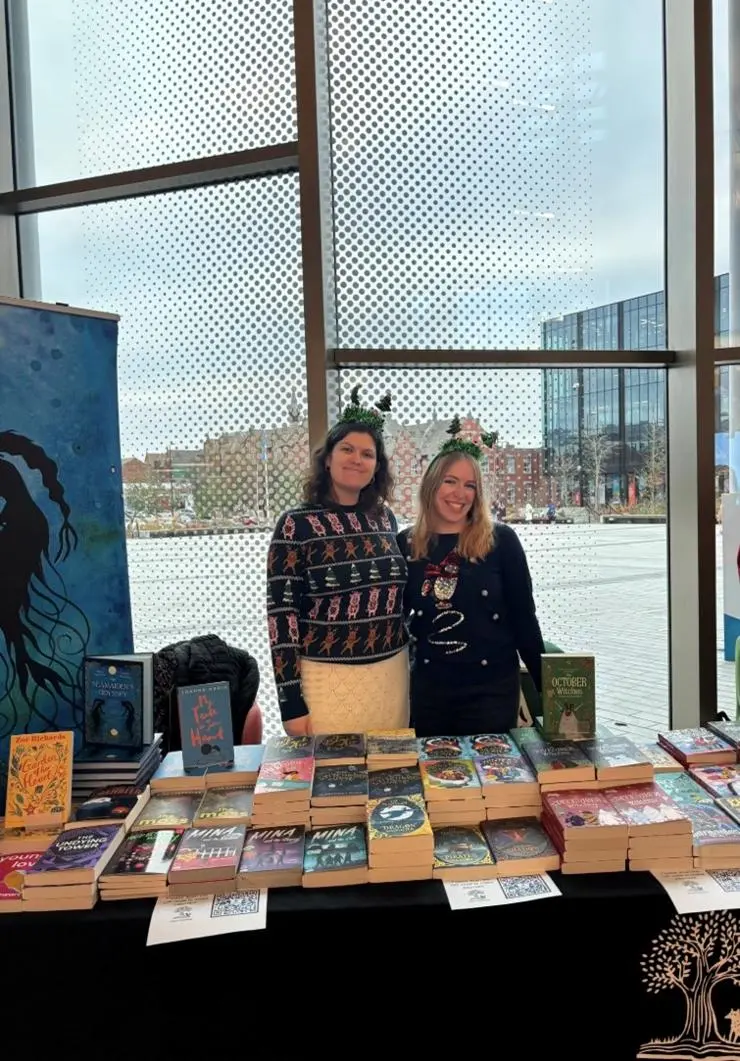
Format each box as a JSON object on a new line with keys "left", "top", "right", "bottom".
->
{"left": 0, "top": 431, "right": 90, "bottom": 740}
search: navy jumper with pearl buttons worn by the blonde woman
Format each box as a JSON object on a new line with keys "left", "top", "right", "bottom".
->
{"left": 398, "top": 523, "right": 545, "bottom": 690}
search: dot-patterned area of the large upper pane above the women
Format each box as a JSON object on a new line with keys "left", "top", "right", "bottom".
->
{"left": 328, "top": 0, "right": 598, "bottom": 349}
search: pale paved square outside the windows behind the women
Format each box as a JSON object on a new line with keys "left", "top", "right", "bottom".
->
{"left": 128, "top": 524, "right": 735, "bottom": 738}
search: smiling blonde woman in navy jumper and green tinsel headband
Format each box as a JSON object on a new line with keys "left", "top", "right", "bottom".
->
{"left": 398, "top": 418, "right": 545, "bottom": 736}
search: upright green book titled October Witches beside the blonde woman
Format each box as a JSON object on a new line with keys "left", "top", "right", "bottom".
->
{"left": 543, "top": 653, "right": 596, "bottom": 741}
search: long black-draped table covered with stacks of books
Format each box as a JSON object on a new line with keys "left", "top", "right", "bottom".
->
{"left": 7, "top": 717, "right": 740, "bottom": 1061}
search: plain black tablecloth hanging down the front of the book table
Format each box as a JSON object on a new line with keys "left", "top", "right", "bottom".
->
{"left": 0, "top": 873, "right": 726, "bottom": 1061}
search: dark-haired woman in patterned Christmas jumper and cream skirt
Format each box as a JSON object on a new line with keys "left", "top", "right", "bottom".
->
{"left": 268, "top": 388, "right": 409, "bottom": 736}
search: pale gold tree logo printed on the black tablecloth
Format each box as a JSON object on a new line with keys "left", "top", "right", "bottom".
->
{"left": 637, "top": 910, "right": 740, "bottom": 1061}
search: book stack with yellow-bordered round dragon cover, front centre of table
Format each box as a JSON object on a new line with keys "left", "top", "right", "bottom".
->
{"left": 367, "top": 793, "right": 434, "bottom": 884}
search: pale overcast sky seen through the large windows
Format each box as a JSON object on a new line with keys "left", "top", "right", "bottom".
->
{"left": 13, "top": 0, "right": 729, "bottom": 456}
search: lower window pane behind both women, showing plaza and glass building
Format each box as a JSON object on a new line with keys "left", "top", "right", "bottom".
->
{"left": 329, "top": 366, "right": 669, "bottom": 734}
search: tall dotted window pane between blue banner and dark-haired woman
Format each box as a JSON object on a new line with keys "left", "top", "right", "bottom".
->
{"left": 24, "top": 174, "right": 308, "bottom": 728}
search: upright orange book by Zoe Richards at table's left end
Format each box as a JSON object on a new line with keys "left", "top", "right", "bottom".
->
{"left": 5, "top": 730, "right": 74, "bottom": 829}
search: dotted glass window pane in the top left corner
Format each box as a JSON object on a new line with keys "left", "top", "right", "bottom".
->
{"left": 23, "top": 0, "right": 296, "bottom": 182}
